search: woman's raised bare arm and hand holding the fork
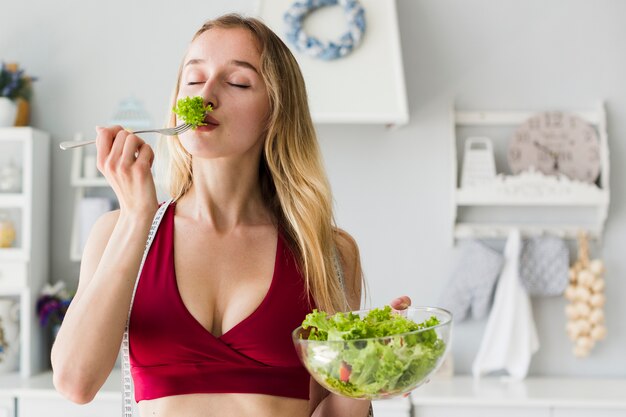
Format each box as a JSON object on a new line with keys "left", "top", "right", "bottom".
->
{"left": 51, "top": 127, "right": 158, "bottom": 404}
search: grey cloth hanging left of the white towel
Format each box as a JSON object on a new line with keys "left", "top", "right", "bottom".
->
{"left": 439, "top": 240, "right": 504, "bottom": 321}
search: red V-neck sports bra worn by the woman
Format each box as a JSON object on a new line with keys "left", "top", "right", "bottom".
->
{"left": 129, "top": 203, "right": 313, "bottom": 401}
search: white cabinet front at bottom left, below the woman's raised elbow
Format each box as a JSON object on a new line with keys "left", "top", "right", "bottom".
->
{"left": 18, "top": 398, "right": 122, "bottom": 417}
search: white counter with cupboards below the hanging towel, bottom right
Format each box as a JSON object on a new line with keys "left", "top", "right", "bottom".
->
{"left": 411, "top": 376, "right": 626, "bottom": 417}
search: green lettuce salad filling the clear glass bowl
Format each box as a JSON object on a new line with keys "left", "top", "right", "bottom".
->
{"left": 302, "top": 306, "right": 446, "bottom": 397}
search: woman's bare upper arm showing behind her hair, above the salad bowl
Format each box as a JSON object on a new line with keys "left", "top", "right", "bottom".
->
{"left": 335, "top": 228, "right": 363, "bottom": 309}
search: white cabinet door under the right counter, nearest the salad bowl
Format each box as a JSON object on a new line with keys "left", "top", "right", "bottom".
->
{"left": 413, "top": 405, "right": 548, "bottom": 417}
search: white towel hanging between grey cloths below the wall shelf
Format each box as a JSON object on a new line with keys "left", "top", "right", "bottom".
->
{"left": 472, "top": 230, "right": 539, "bottom": 380}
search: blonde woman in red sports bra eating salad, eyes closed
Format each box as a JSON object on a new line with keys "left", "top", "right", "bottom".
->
{"left": 52, "top": 15, "right": 410, "bottom": 417}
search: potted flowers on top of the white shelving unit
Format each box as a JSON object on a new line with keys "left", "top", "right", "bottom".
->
{"left": 0, "top": 62, "right": 35, "bottom": 127}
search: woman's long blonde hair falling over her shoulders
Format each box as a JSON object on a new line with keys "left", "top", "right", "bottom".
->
{"left": 160, "top": 14, "right": 361, "bottom": 312}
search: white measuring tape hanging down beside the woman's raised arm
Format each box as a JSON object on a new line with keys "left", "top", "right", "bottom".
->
{"left": 122, "top": 198, "right": 173, "bottom": 417}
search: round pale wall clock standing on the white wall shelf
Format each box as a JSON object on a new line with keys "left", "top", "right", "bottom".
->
{"left": 508, "top": 111, "right": 600, "bottom": 183}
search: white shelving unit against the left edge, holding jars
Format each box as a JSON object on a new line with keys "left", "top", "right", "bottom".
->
{"left": 0, "top": 127, "right": 50, "bottom": 377}
